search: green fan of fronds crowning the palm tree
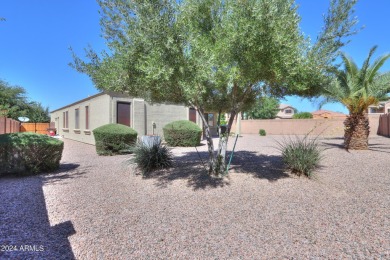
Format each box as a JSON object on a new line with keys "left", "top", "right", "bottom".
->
{"left": 323, "top": 46, "right": 390, "bottom": 115}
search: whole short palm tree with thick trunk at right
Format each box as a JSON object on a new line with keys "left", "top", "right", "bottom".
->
{"left": 323, "top": 46, "right": 390, "bottom": 150}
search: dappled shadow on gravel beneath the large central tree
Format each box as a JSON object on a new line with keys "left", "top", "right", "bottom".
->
{"left": 144, "top": 151, "right": 289, "bottom": 190}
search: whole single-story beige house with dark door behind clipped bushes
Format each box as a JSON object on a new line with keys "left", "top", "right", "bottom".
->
{"left": 50, "top": 92, "right": 217, "bottom": 145}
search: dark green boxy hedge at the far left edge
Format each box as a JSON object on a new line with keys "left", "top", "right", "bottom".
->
{"left": 0, "top": 132, "right": 64, "bottom": 176}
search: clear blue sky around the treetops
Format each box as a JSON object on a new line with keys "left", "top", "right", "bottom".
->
{"left": 0, "top": 0, "right": 390, "bottom": 113}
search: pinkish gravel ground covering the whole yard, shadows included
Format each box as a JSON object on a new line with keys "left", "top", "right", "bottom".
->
{"left": 0, "top": 135, "right": 390, "bottom": 259}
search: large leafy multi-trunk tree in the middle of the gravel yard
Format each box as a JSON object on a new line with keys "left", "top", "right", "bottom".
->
{"left": 71, "top": 0, "right": 356, "bottom": 176}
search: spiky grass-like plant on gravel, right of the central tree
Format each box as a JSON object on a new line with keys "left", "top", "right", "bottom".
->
{"left": 279, "top": 135, "right": 322, "bottom": 178}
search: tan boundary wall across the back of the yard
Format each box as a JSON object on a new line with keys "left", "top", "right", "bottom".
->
{"left": 232, "top": 115, "right": 379, "bottom": 137}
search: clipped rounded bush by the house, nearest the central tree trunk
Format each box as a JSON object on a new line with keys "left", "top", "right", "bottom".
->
{"left": 163, "top": 120, "right": 202, "bottom": 146}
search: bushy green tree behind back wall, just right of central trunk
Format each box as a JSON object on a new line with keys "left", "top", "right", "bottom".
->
{"left": 248, "top": 96, "right": 279, "bottom": 119}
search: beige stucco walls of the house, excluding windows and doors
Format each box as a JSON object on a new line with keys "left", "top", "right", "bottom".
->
{"left": 51, "top": 93, "right": 195, "bottom": 145}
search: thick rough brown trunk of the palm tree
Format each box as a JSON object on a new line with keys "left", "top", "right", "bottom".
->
{"left": 344, "top": 114, "right": 370, "bottom": 150}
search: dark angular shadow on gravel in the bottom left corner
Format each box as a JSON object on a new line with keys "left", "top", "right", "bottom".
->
{"left": 0, "top": 176, "right": 76, "bottom": 259}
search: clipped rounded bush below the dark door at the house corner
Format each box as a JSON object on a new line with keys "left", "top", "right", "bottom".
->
{"left": 93, "top": 124, "right": 137, "bottom": 155}
